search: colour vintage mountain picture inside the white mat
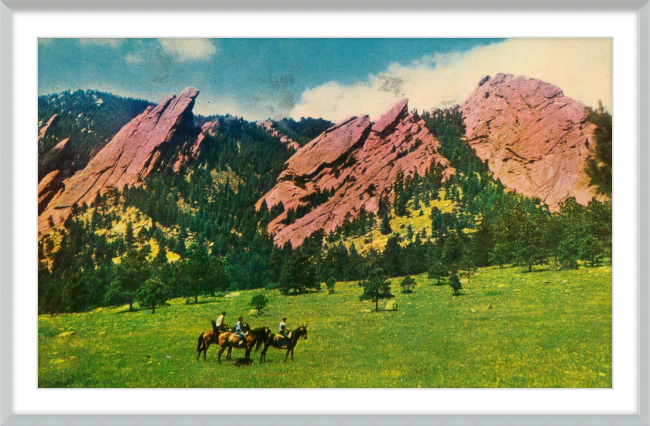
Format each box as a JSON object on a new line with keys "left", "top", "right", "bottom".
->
{"left": 38, "top": 38, "right": 613, "bottom": 388}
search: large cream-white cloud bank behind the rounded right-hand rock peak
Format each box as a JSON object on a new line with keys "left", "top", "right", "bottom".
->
{"left": 291, "top": 39, "right": 612, "bottom": 121}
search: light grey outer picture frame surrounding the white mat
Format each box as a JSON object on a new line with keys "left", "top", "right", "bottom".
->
{"left": 0, "top": 0, "right": 650, "bottom": 426}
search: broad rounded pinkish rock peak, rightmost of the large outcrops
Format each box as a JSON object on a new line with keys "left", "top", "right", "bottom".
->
{"left": 461, "top": 74, "right": 596, "bottom": 211}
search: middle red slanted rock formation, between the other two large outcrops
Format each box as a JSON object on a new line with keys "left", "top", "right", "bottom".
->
{"left": 257, "top": 99, "right": 455, "bottom": 247}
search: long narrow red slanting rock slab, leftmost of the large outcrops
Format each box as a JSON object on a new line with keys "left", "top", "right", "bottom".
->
{"left": 38, "top": 87, "right": 199, "bottom": 233}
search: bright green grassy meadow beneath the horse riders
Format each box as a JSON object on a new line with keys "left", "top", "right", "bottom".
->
{"left": 38, "top": 266, "right": 612, "bottom": 388}
